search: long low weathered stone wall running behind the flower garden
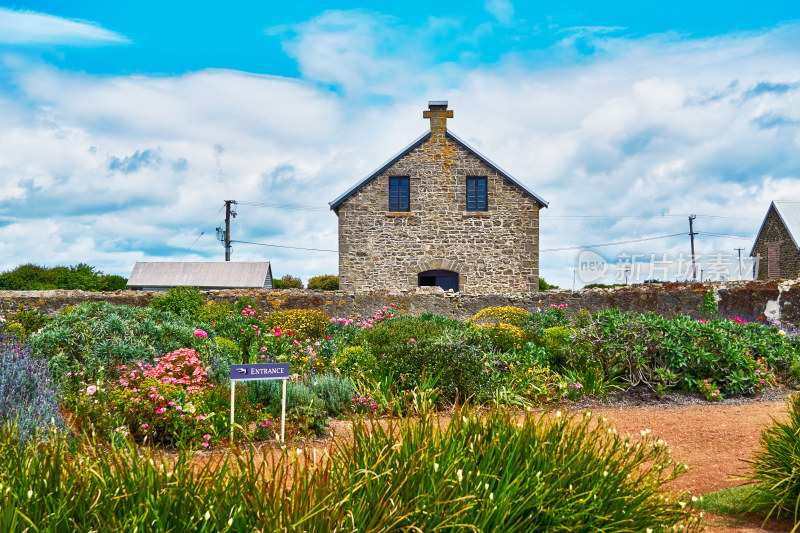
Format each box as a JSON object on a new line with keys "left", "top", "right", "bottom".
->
{"left": 0, "top": 280, "right": 800, "bottom": 324}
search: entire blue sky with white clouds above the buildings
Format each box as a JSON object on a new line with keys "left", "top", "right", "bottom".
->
{"left": 0, "top": 0, "right": 800, "bottom": 287}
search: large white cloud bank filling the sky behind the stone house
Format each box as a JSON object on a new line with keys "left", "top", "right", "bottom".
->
{"left": 0, "top": 12, "right": 800, "bottom": 286}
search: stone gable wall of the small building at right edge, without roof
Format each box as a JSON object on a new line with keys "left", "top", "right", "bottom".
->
{"left": 751, "top": 203, "right": 800, "bottom": 280}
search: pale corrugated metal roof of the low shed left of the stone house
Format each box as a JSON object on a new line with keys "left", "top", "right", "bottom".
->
{"left": 128, "top": 261, "right": 272, "bottom": 289}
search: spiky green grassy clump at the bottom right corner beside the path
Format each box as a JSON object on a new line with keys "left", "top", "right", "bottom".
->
{"left": 746, "top": 394, "right": 800, "bottom": 526}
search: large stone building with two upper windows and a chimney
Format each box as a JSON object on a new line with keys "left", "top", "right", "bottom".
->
{"left": 330, "top": 101, "right": 547, "bottom": 294}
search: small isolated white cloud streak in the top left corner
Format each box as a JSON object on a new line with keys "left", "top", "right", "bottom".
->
{"left": 0, "top": 7, "right": 130, "bottom": 45}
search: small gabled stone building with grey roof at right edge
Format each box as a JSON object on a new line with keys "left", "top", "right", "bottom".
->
{"left": 750, "top": 201, "right": 800, "bottom": 279}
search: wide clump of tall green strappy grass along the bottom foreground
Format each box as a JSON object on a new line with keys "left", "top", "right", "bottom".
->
{"left": 0, "top": 412, "right": 700, "bottom": 532}
